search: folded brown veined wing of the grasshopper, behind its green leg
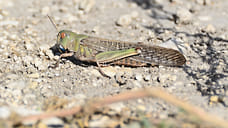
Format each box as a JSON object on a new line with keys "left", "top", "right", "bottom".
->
{"left": 81, "top": 37, "right": 186, "bottom": 66}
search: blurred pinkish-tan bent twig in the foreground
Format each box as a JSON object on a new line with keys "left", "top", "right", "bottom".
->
{"left": 18, "top": 88, "right": 228, "bottom": 128}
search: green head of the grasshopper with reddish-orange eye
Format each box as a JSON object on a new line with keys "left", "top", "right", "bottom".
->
{"left": 57, "top": 30, "right": 73, "bottom": 53}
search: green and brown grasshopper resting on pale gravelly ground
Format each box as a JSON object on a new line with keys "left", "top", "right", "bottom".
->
{"left": 49, "top": 15, "right": 186, "bottom": 77}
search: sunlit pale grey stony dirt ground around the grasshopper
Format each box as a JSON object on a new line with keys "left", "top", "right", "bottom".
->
{"left": 0, "top": 0, "right": 228, "bottom": 126}
